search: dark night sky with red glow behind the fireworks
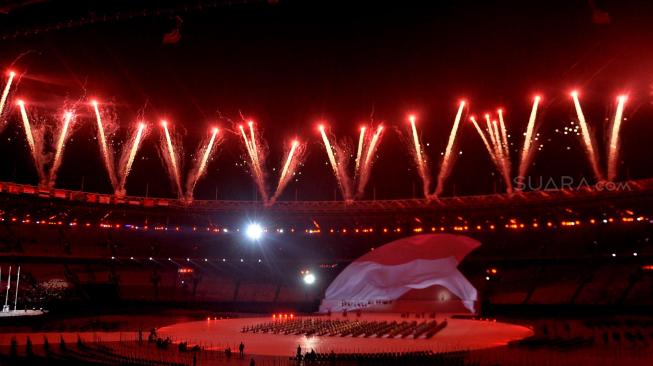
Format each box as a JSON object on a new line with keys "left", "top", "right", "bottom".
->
{"left": 0, "top": 0, "right": 653, "bottom": 200}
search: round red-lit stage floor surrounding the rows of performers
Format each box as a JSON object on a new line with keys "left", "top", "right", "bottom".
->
{"left": 158, "top": 313, "right": 533, "bottom": 356}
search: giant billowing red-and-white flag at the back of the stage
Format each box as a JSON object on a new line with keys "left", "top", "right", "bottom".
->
{"left": 321, "top": 234, "right": 481, "bottom": 312}
